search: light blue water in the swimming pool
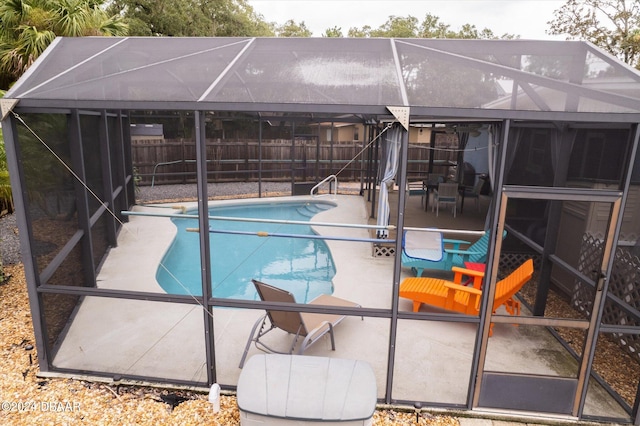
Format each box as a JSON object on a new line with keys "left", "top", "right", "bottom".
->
{"left": 156, "top": 202, "right": 336, "bottom": 303}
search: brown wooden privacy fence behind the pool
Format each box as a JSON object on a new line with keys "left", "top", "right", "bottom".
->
{"left": 131, "top": 139, "right": 455, "bottom": 185}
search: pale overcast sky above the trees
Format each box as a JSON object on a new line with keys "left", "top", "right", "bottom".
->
{"left": 248, "top": 0, "right": 565, "bottom": 39}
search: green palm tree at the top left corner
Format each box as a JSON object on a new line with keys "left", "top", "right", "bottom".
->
{"left": 0, "top": 0, "right": 127, "bottom": 89}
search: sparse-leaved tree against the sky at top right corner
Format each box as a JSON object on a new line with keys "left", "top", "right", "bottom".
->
{"left": 548, "top": 0, "right": 640, "bottom": 68}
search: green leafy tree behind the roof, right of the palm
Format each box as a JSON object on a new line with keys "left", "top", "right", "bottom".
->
{"left": 108, "top": 0, "right": 274, "bottom": 37}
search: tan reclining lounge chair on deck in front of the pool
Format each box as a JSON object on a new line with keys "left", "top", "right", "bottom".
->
{"left": 239, "top": 280, "right": 360, "bottom": 368}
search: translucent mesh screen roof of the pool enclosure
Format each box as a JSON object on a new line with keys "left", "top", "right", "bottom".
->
{"left": 5, "top": 37, "right": 640, "bottom": 121}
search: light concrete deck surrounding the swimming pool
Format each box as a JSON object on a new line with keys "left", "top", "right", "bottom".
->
{"left": 53, "top": 191, "right": 627, "bottom": 420}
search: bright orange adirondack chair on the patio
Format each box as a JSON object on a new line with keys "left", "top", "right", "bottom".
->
{"left": 400, "top": 259, "right": 533, "bottom": 335}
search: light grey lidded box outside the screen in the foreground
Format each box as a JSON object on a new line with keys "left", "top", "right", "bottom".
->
{"left": 237, "top": 354, "right": 377, "bottom": 426}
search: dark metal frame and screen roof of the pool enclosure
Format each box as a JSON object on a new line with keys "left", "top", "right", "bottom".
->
{"left": 0, "top": 37, "right": 640, "bottom": 425}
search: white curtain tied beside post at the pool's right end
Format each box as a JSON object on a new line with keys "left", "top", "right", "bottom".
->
{"left": 377, "top": 124, "right": 402, "bottom": 238}
